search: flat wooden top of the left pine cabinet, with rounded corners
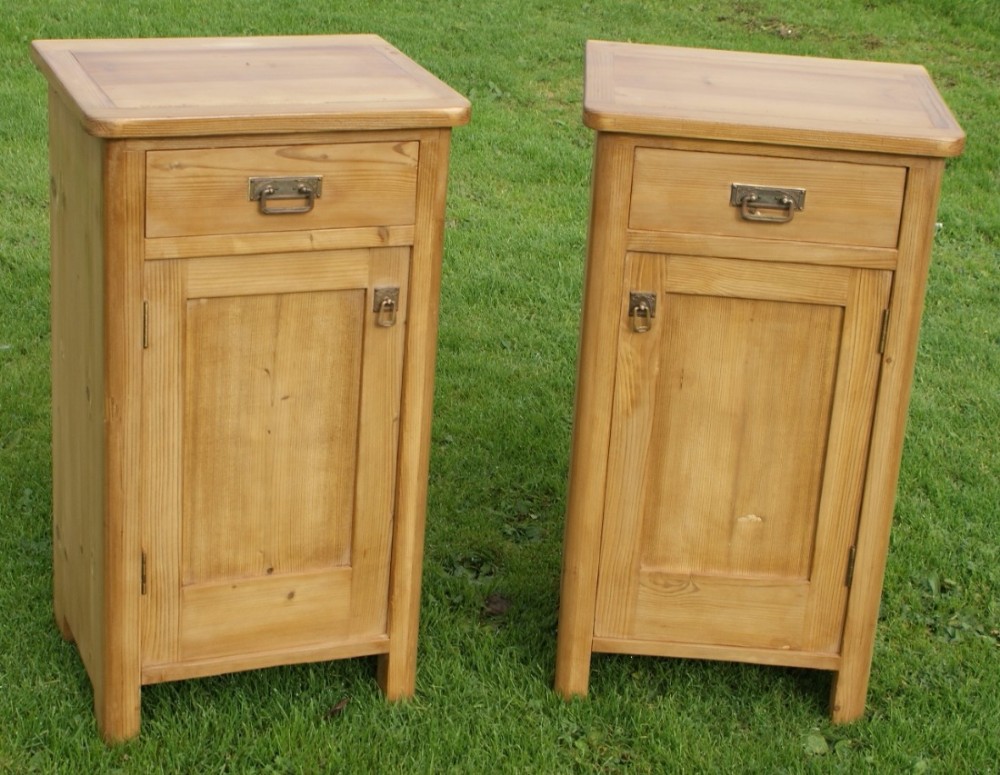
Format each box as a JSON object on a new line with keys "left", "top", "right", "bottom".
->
{"left": 31, "top": 35, "right": 470, "bottom": 138}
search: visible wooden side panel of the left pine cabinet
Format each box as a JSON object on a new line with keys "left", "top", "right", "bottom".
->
{"left": 49, "top": 92, "right": 105, "bottom": 685}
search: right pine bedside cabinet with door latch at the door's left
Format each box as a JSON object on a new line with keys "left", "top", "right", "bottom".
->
{"left": 556, "top": 41, "right": 964, "bottom": 721}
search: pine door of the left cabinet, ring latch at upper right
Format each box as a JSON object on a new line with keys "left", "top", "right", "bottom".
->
{"left": 140, "top": 248, "right": 409, "bottom": 665}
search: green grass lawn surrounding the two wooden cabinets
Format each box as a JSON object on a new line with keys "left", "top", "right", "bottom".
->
{"left": 0, "top": 0, "right": 1000, "bottom": 773}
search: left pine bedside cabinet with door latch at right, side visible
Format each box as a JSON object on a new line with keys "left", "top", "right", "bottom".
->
{"left": 33, "top": 36, "right": 469, "bottom": 740}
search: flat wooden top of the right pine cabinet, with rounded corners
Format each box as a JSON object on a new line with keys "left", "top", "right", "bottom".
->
{"left": 584, "top": 40, "right": 965, "bottom": 156}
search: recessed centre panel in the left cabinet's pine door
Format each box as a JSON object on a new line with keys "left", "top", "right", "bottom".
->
{"left": 181, "top": 289, "right": 365, "bottom": 585}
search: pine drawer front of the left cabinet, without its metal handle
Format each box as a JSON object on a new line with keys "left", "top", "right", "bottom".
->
{"left": 146, "top": 141, "right": 420, "bottom": 238}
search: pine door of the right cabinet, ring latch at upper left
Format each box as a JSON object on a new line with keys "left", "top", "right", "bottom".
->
{"left": 595, "top": 253, "right": 891, "bottom": 653}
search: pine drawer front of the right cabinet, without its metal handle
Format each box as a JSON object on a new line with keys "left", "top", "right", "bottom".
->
{"left": 629, "top": 148, "right": 906, "bottom": 248}
